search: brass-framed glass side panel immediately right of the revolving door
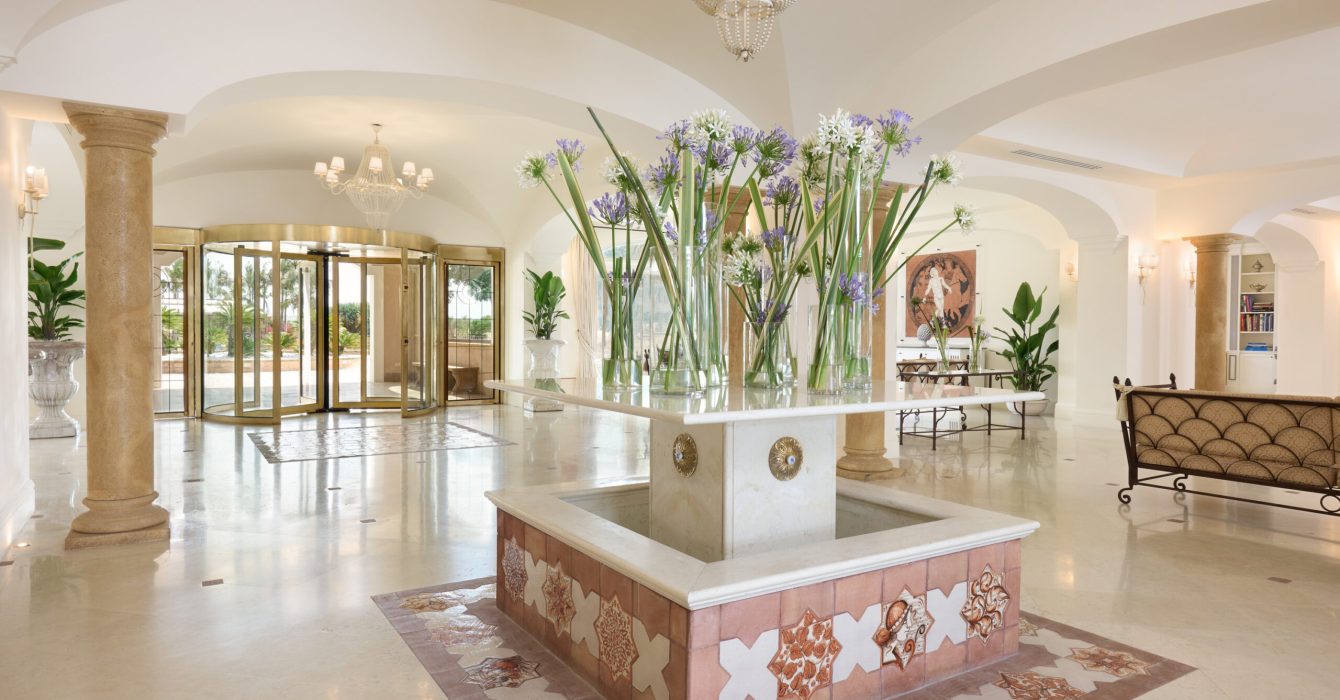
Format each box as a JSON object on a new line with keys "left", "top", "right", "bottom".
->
{"left": 444, "top": 261, "right": 501, "bottom": 404}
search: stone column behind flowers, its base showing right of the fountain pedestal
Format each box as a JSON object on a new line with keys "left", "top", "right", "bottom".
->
{"left": 838, "top": 185, "right": 899, "bottom": 480}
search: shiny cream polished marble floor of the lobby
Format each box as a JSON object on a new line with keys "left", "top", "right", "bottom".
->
{"left": 0, "top": 406, "right": 1340, "bottom": 699}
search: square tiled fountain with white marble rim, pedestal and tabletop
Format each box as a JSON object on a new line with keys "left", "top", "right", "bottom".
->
{"left": 488, "top": 381, "right": 1041, "bottom": 700}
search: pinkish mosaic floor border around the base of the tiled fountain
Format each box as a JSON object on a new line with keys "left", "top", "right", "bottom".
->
{"left": 373, "top": 578, "right": 1195, "bottom": 700}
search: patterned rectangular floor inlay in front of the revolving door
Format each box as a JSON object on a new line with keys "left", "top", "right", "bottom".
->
{"left": 247, "top": 422, "right": 513, "bottom": 464}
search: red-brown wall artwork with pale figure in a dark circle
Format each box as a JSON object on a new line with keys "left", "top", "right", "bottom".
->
{"left": 903, "top": 249, "right": 977, "bottom": 338}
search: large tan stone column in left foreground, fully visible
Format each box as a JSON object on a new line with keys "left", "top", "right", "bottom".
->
{"left": 64, "top": 102, "right": 168, "bottom": 548}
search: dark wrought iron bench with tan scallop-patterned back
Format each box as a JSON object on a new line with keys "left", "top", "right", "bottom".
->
{"left": 1114, "top": 378, "right": 1340, "bottom": 515}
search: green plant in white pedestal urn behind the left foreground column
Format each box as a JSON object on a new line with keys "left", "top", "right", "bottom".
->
{"left": 28, "top": 239, "right": 84, "bottom": 439}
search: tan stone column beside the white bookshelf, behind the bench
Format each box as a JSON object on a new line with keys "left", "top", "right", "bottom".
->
{"left": 1186, "top": 233, "right": 1238, "bottom": 392}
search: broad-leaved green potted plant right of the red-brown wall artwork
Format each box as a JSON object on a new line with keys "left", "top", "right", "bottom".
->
{"left": 996, "top": 282, "right": 1061, "bottom": 416}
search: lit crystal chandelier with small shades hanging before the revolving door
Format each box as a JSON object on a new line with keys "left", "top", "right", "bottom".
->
{"left": 312, "top": 123, "right": 433, "bottom": 228}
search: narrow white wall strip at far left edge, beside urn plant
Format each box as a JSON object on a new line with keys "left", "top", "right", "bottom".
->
{"left": 0, "top": 101, "right": 34, "bottom": 551}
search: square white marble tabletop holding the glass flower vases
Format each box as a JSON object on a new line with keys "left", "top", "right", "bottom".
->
{"left": 484, "top": 380, "right": 1047, "bottom": 425}
